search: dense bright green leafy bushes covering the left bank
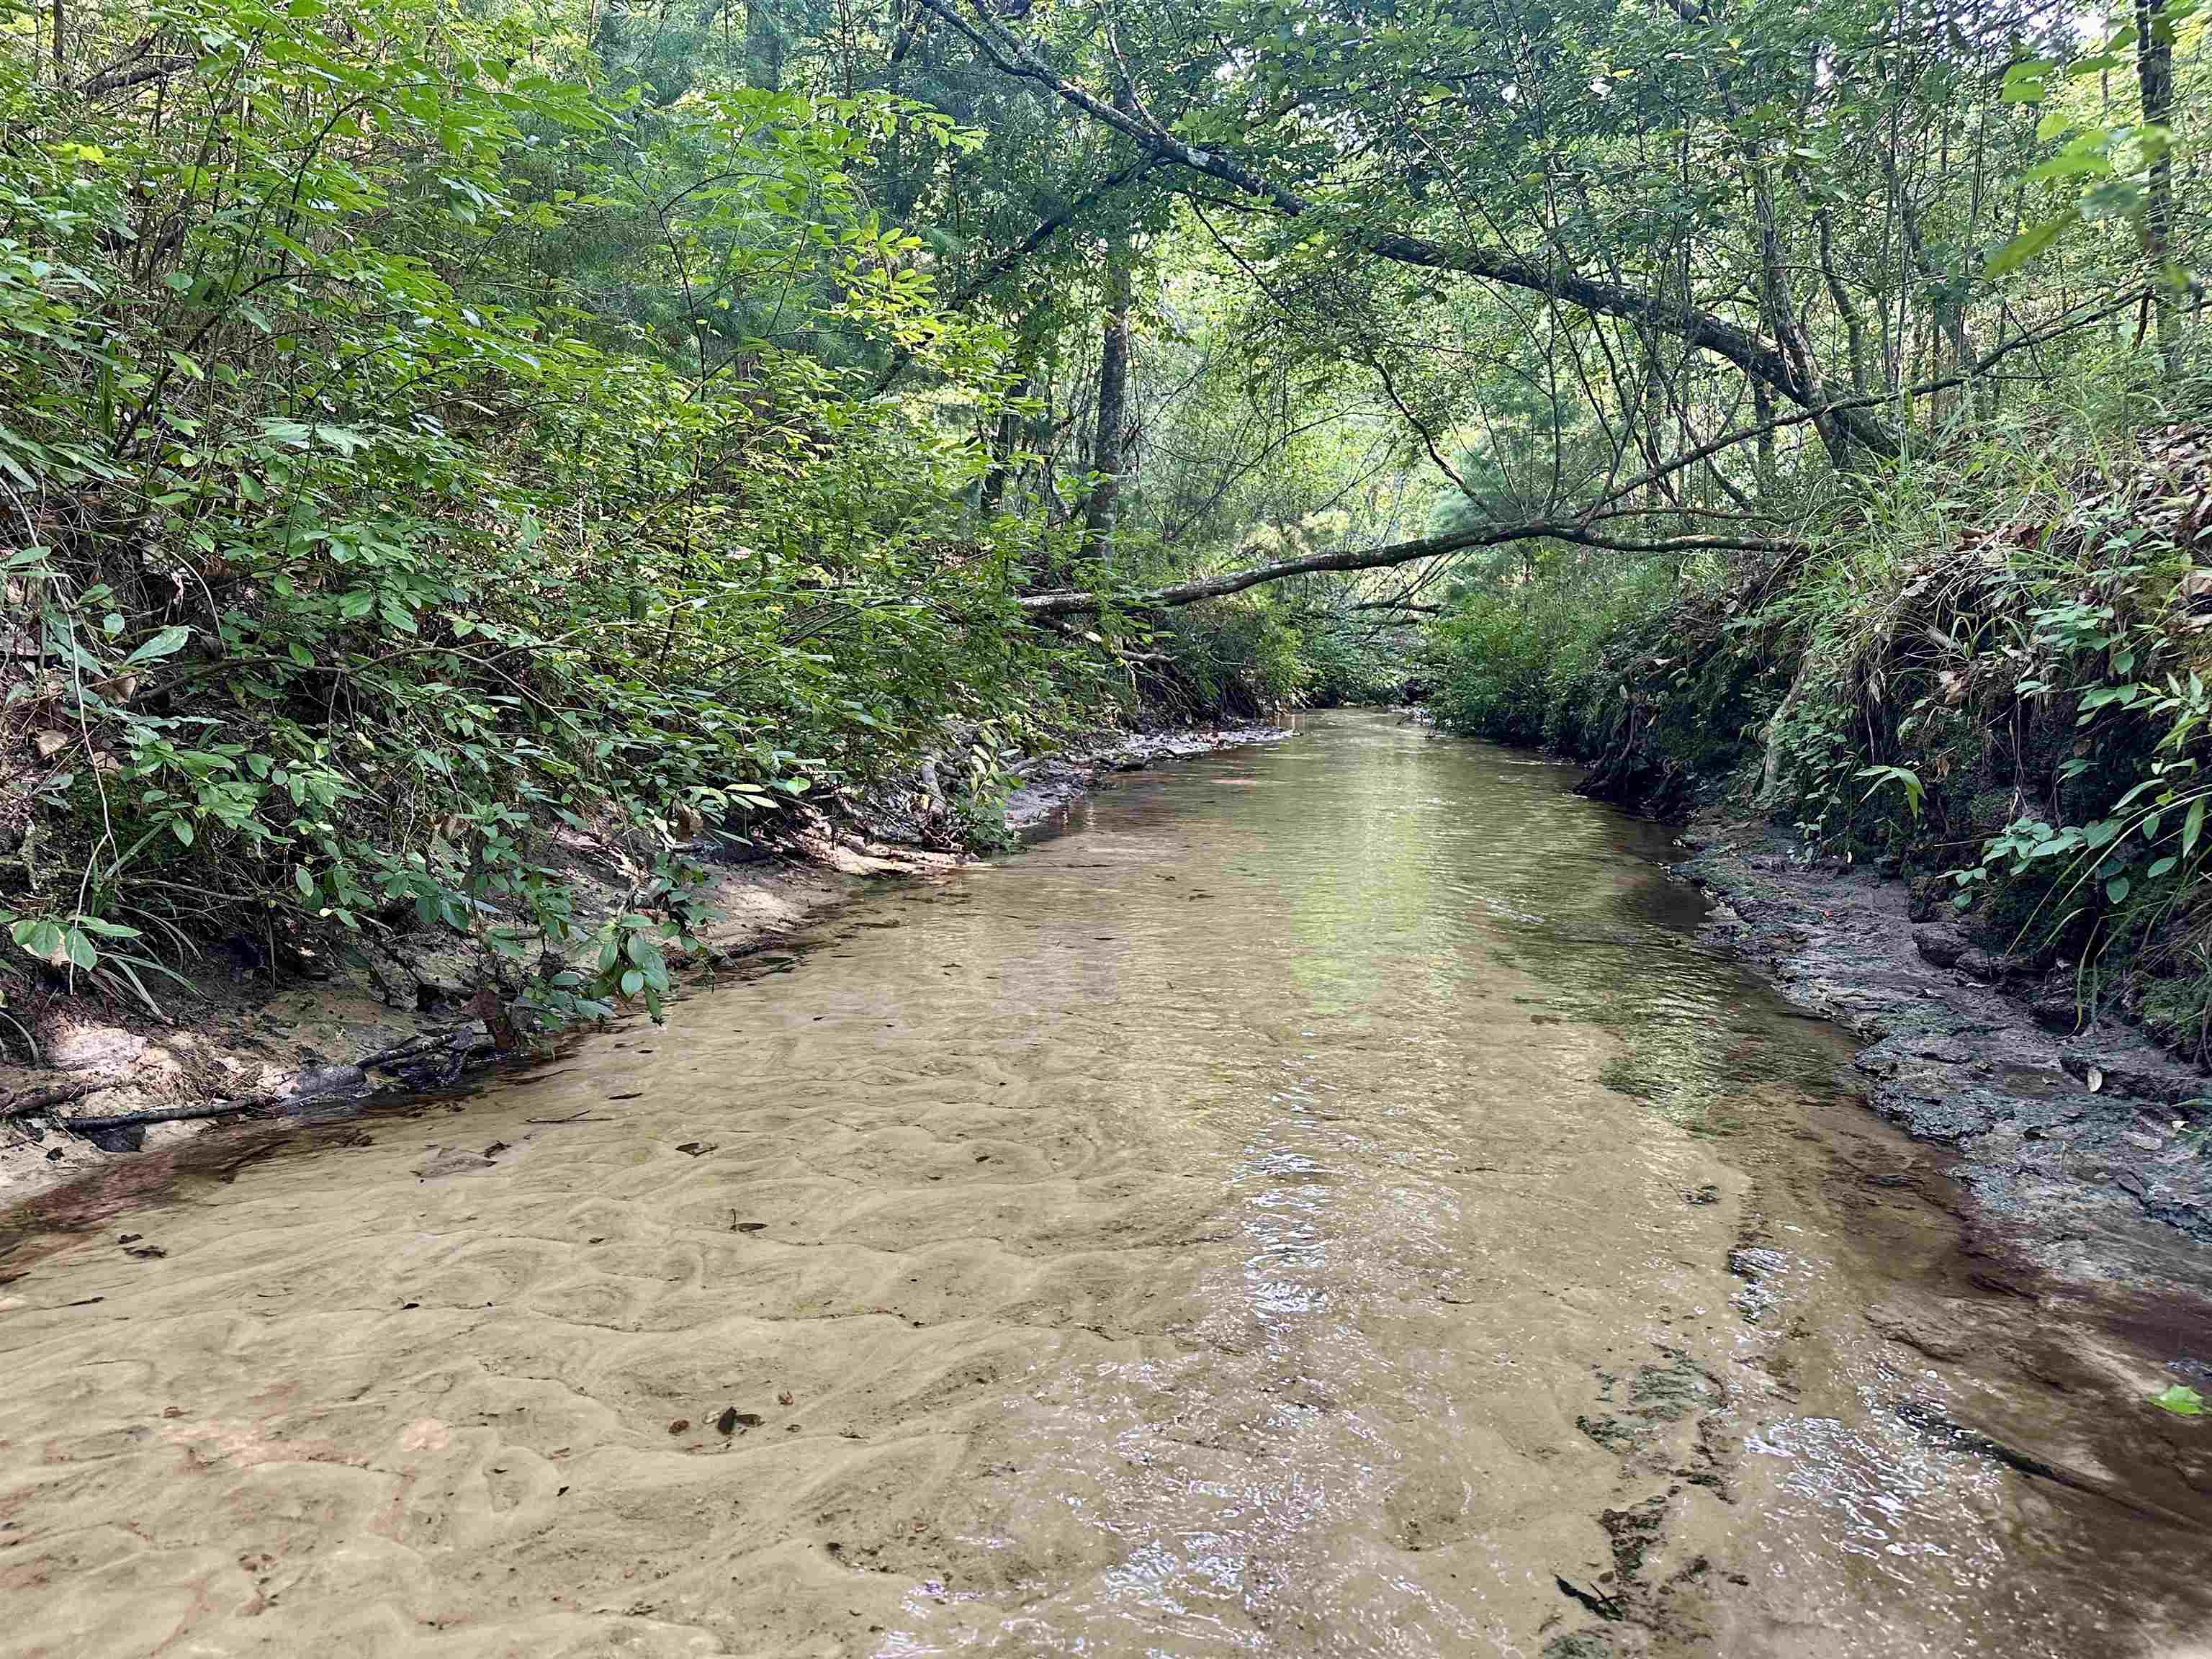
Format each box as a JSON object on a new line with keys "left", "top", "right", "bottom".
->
{"left": 0, "top": 4, "right": 1088, "bottom": 1035}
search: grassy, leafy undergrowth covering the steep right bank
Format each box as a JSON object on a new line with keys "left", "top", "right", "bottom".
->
{"left": 1426, "top": 365, "right": 2212, "bottom": 1055}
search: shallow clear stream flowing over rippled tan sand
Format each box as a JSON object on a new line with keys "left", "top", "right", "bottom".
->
{"left": 0, "top": 714, "right": 2212, "bottom": 1659}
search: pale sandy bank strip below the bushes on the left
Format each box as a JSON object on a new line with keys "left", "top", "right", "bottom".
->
{"left": 0, "top": 724, "right": 1287, "bottom": 1205}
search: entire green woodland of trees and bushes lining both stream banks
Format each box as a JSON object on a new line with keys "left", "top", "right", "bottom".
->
{"left": 0, "top": 0, "right": 2212, "bottom": 1070}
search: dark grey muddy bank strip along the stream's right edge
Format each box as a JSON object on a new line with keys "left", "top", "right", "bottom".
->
{"left": 1677, "top": 814, "right": 2212, "bottom": 1277}
